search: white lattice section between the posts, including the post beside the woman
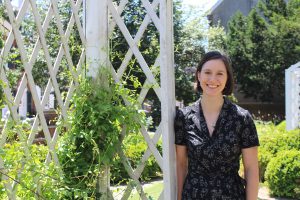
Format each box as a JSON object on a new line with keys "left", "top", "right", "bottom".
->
{"left": 91, "top": 0, "right": 176, "bottom": 199}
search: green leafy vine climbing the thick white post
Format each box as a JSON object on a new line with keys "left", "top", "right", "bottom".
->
{"left": 58, "top": 70, "right": 145, "bottom": 198}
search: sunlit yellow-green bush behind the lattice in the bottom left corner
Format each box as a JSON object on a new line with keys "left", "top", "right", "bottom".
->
{"left": 0, "top": 141, "right": 59, "bottom": 199}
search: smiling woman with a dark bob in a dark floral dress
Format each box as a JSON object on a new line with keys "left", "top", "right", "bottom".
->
{"left": 174, "top": 51, "right": 259, "bottom": 200}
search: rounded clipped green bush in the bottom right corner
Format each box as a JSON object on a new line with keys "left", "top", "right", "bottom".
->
{"left": 265, "top": 149, "right": 300, "bottom": 198}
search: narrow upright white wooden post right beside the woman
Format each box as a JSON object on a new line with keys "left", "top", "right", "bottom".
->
{"left": 159, "top": 0, "right": 176, "bottom": 200}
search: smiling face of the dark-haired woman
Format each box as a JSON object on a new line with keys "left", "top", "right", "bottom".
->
{"left": 198, "top": 59, "right": 228, "bottom": 96}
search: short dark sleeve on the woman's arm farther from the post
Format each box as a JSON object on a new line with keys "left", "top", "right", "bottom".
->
{"left": 241, "top": 111, "right": 259, "bottom": 148}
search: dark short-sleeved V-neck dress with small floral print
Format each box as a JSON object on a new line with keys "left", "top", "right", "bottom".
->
{"left": 174, "top": 97, "right": 259, "bottom": 200}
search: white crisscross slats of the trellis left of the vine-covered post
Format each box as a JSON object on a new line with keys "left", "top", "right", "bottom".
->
{"left": 0, "top": 0, "right": 85, "bottom": 199}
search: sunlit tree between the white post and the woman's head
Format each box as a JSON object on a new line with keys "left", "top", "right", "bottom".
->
{"left": 174, "top": 4, "right": 208, "bottom": 105}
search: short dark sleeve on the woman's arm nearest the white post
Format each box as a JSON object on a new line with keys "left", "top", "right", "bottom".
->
{"left": 174, "top": 109, "right": 186, "bottom": 145}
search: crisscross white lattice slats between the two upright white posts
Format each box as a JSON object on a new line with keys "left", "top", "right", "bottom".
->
{"left": 108, "top": 0, "right": 163, "bottom": 199}
